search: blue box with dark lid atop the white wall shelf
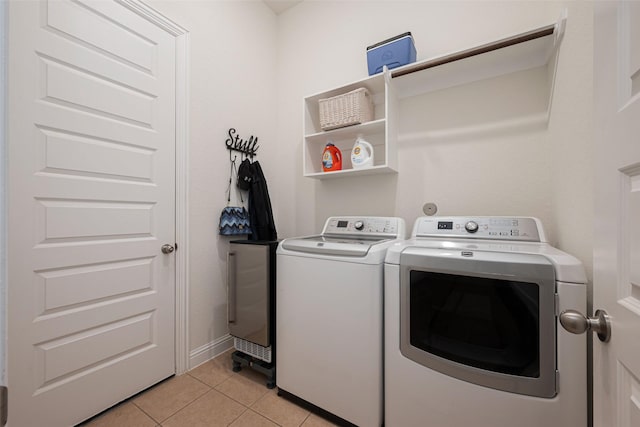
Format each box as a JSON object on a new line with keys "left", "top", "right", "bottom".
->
{"left": 367, "top": 33, "right": 416, "bottom": 76}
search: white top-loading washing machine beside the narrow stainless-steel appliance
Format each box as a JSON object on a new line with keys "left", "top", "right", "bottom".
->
{"left": 276, "top": 217, "right": 405, "bottom": 427}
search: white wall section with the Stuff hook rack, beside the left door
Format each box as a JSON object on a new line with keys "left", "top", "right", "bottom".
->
{"left": 149, "top": 0, "right": 277, "bottom": 367}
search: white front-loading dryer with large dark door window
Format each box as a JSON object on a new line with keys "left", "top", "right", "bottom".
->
{"left": 384, "top": 217, "right": 587, "bottom": 427}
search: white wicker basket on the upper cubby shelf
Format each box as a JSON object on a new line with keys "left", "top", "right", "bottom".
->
{"left": 318, "top": 88, "right": 373, "bottom": 130}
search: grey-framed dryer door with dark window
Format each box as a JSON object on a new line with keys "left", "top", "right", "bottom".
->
{"left": 400, "top": 248, "right": 557, "bottom": 398}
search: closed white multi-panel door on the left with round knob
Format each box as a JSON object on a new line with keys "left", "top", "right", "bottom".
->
{"left": 8, "top": 0, "right": 175, "bottom": 427}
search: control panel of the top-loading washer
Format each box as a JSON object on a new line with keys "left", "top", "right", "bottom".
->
{"left": 322, "top": 216, "right": 405, "bottom": 239}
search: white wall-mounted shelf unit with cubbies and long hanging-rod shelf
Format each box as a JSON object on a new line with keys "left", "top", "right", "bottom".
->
{"left": 303, "top": 16, "right": 566, "bottom": 179}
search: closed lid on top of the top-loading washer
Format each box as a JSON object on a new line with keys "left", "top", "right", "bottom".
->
{"left": 282, "top": 234, "right": 391, "bottom": 257}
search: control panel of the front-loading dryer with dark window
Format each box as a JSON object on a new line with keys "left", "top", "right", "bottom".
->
{"left": 412, "top": 216, "right": 546, "bottom": 242}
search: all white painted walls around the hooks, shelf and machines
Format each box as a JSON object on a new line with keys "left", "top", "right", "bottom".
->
{"left": 150, "top": 0, "right": 593, "bottom": 372}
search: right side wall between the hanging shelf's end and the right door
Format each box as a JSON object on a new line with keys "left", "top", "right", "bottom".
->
{"left": 549, "top": 2, "right": 595, "bottom": 290}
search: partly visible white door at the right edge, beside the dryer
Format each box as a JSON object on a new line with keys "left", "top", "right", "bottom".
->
{"left": 585, "top": 1, "right": 640, "bottom": 427}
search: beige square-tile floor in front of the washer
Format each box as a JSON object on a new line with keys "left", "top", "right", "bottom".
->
{"left": 80, "top": 350, "right": 334, "bottom": 427}
